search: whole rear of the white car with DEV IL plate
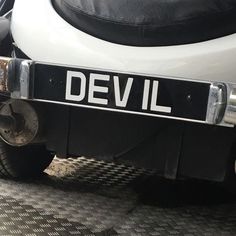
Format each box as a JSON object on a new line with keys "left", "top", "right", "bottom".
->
{"left": 0, "top": 0, "right": 236, "bottom": 188}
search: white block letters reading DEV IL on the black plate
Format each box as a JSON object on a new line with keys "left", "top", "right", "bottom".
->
{"left": 65, "top": 71, "right": 172, "bottom": 113}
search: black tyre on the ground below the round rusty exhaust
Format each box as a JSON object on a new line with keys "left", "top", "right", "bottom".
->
{"left": 0, "top": 140, "right": 54, "bottom": 178}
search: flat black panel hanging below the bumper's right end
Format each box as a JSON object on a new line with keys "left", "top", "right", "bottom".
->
{"left": 178, "top": 124, "right": 236, "bottom": 182}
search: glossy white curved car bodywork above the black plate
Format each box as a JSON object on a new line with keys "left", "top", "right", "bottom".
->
{"left": 11, "top": 0, "right": 236, "bottom": 84}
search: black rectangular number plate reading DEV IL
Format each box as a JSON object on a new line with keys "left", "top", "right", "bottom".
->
{"left": 33, "top": 63, "right": 211, "bottom": 122}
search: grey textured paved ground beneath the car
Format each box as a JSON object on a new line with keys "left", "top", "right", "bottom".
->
{"left": 0, "top": 158, "right": 236, "bottom": 236}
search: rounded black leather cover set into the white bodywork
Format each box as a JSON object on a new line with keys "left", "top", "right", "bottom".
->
{"left": 52, "top": 0, "right": 236, "bottom": 46}
